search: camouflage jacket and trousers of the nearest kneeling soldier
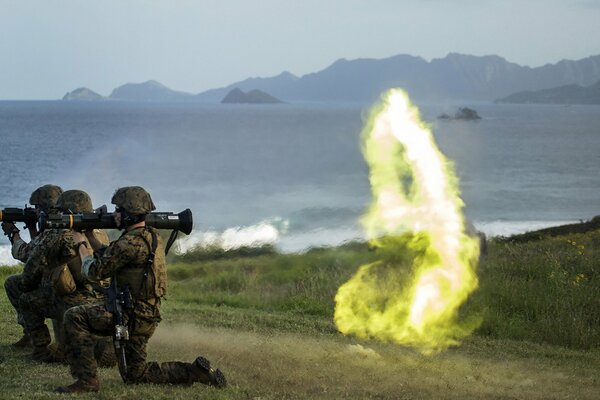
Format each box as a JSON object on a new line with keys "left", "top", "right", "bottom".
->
{"left": 65, "top": 228, "right": 200, "bottom": 383}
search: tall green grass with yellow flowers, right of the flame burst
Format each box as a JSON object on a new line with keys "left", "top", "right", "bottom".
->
{"left": 469, "top": 231, "right": 600, "bottom": 349}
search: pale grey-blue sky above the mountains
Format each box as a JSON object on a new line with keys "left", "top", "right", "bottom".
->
{"left": 0, "top": 0, "right": 600, "bottom": 99}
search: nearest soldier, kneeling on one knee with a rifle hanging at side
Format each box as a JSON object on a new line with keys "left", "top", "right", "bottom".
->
{"left": 57, "top": 186, "right": 226, "bottom": 393}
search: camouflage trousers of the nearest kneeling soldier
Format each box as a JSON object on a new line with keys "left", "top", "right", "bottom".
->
{"left": 65, "top": 301, "right": 192, "bottom": 384}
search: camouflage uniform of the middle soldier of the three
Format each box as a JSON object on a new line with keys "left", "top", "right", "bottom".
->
{"left": 19, "top": 229, "right": 108, "bottom": 360}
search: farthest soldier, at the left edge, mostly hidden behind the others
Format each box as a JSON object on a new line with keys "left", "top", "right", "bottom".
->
{"left": 2, "top": 185, "right": 62, "bottom": 347}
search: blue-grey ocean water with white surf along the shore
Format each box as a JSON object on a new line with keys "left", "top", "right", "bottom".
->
{"left": 0, "top": 101, "right": 600, "bottom": 264}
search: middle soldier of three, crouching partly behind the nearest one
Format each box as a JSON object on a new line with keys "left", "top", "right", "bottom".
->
{"left": 19, "top": 190, "right": 116, "bottom": 365}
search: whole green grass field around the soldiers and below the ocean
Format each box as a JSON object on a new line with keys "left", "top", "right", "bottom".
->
{"left": 0, "top": 231, "right": 600, "bottom": 399}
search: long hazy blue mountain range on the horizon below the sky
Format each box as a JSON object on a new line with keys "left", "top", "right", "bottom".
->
{"left": 61, "top": 53, "right": 600, "bottom": 103}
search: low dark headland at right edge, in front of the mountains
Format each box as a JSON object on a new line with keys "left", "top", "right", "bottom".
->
{"left": 496, "top": 81, "right": 600, "bottom": 104}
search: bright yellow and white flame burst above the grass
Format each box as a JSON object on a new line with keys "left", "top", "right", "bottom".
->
{"left": 334, "top": 89, "right": 479, "bottom": 353}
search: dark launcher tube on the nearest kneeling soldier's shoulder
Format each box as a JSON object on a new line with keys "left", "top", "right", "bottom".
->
{"left": 39, "top": 206, "right": 193, "bottom": 235}
